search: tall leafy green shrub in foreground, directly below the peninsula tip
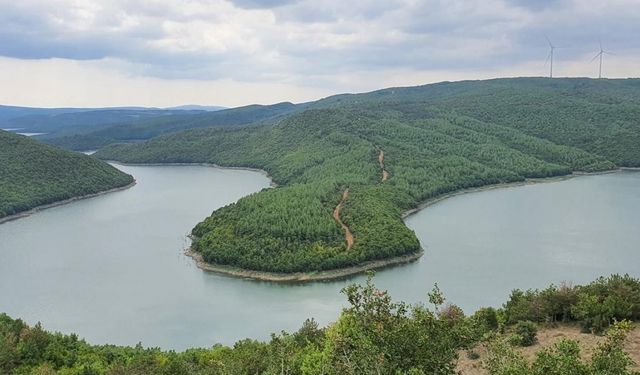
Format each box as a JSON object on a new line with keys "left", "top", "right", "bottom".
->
{"left": 303, "top": 280, "right": 467, "bottom": 375}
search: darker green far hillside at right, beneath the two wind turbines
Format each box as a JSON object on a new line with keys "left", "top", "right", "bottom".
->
{"left": 312, "top": 78, "right": 640, "bottom": 166}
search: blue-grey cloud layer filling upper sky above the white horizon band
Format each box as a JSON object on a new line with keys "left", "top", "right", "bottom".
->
{"left": 0, "top": 0, "right": 640, "bottom": 80}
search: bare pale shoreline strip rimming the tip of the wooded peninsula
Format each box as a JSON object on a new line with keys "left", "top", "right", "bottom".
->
{"left": 184, "top": 247, "right": 424, "bottom": 283}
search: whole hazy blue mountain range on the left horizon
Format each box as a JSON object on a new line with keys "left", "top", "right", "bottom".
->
{"left": 14, "top": 103, "right": 306, "bottom": 150}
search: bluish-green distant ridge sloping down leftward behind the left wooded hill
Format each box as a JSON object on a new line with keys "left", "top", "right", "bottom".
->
{"left": 43, "top": 103, "right": 304, "bottom": 150}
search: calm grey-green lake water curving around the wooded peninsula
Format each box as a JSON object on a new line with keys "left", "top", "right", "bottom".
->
{"left": 0, "top": 166, "right": 640, "bottom": 350}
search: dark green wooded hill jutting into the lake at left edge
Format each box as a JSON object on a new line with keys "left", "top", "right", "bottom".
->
{"left": 0, "top": 130, "right": 133, "bottom": 218}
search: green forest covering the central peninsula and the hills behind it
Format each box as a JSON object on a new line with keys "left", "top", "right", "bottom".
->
{"left": 96, "top": 78, "right": 640, "bottom": 273}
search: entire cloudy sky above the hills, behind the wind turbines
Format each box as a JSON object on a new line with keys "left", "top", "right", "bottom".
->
{"left": 0, "top": 0, "right": 640, "bottom": 107}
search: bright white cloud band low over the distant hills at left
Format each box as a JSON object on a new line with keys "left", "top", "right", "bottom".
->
{"left": 0, "top": 58, "right": 333, "bottom": 107}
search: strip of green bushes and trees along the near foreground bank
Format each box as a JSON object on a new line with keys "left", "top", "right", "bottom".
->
{"left": 0, "top": 275, "right": 640, "bottom": 375}
